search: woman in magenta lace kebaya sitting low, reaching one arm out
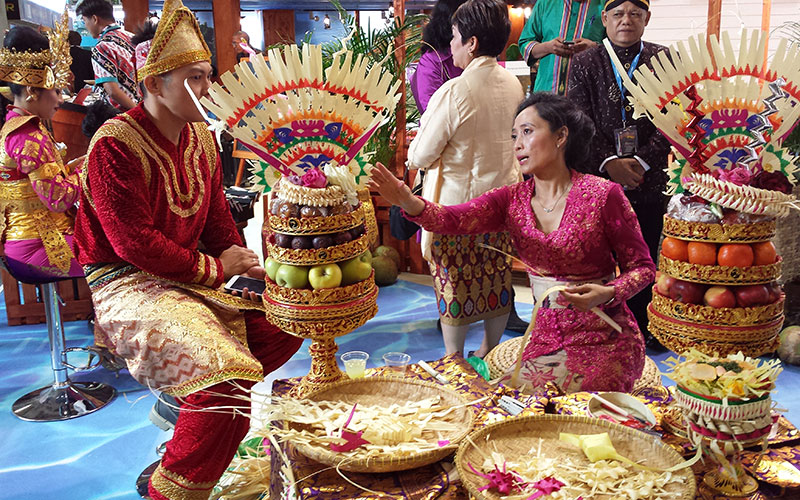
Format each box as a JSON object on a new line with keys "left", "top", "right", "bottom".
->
{"left": 372, "top": 93, "right": 655, "bottom": 392}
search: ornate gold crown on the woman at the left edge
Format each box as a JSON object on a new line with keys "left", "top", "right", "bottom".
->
{"left": 0, "top": 9, "right": 72, "bottom": 89}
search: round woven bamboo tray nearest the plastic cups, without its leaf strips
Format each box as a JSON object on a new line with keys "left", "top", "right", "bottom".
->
{"left": 290, "top": 377, "right": 475, "bottom": 472}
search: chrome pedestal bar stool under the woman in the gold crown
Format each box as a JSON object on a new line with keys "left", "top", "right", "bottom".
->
{"left": 0, "top": 256, "right": 117, "bottom": 422}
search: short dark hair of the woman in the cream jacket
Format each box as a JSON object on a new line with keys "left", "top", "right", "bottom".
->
{"left": 453, "top": 0, "right": 511, "bottom": 57}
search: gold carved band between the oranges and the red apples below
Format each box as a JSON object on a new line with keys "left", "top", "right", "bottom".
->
{"left": 658, "top": 255, "right": 783, "bottom": 285}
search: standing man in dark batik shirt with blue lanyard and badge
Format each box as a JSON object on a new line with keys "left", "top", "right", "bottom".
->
{"left": 567, "top": 0, "right": 669, "bottom": 347}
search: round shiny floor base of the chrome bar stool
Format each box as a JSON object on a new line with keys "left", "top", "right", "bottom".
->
{"left": 12, "top": 381, "right": 117, "bottom": 422}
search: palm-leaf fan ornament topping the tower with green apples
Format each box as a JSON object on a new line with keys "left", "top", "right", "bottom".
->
{"left": 202, "top": 44, "right": 400, "bottom": 191}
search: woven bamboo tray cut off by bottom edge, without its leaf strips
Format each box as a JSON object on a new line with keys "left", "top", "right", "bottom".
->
{"left": 456, "top": 415, "right": 696, "bottom": 500}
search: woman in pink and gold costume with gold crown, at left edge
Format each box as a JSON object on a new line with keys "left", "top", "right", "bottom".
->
{"left": 0, "top": 27, "right": 83, "bottom": 281}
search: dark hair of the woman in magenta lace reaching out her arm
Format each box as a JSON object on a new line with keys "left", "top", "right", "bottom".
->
{"left": 515, "top": 92, "right": 594, "bottom": 171}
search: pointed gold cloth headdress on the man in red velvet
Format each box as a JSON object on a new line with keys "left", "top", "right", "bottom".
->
{"left": 136, "top": 0, "right": 211, "bottom": 82}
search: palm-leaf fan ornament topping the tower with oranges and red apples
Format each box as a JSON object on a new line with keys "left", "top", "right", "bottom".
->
{"left": 604, "top": 30, "right": 800, "bottom": 216}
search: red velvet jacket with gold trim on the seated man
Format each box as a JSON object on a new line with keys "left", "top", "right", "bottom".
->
{"left": 75, "top": 104, "right": 242, "bottom": 287}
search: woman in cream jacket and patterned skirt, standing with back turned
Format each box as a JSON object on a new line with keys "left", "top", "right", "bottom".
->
{"left": 407, "top": 0, "right": 523, "bottom": 357}
